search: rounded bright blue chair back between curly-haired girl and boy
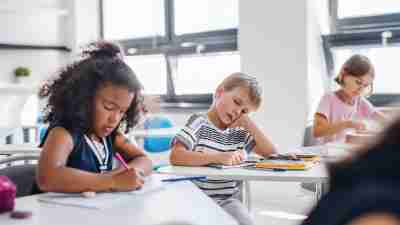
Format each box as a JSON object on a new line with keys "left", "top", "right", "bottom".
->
{"left": 143, "top": 116, "right": 174, "bottom": 152}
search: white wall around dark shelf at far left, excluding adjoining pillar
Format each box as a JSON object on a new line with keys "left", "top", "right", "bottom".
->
{"left": 0, "top": 0, "right": 65, "bottom": 83}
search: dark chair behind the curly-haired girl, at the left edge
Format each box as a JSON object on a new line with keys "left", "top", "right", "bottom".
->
{"left": 0, "top": 155, "right": 39, "bottom": 197}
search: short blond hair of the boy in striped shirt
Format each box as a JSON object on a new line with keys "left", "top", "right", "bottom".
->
{"left": 218, "top": 72, "right": 262, "bottom": 109}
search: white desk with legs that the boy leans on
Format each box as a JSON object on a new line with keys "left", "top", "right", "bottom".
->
{"left": 157, "top": 163, "right": 328, "bottom": 209}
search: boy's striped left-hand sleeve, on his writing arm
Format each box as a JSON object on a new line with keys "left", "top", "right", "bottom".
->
{"left": 173, "top": 114, "right": 205, "bottom": 151}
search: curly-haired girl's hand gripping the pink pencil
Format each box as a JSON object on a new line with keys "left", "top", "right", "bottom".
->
{"left": 112, "top": 168, "right": 144, "bottom": 191}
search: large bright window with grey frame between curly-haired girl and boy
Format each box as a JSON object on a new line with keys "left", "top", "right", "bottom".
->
{"left": 101, "top": 0, "right": 240, "bottom": 106}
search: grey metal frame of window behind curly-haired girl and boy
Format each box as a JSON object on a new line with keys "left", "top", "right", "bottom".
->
{"left": 100, "top": 0, "right": 238, "bottom": 108}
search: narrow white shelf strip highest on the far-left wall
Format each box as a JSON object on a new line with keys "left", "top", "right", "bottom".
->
{"left": 0, "top": 5, "right": 68, "bottom": 16}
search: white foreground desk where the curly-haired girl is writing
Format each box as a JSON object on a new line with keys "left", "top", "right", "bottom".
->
{"left": 0, "top": 181, "right": 237, "bottom": 225}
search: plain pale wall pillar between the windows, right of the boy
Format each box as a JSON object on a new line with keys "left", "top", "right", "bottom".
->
{"left": 239, "top": 0, "right": 325, "bottom": 150}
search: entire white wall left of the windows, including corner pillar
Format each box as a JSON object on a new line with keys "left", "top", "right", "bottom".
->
{"left": 0, "top": 0, "right": 100, "bottom": 83}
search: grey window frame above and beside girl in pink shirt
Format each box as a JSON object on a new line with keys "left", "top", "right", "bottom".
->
{"left": 322, "top": 0, "right": 400, "bottom": 106}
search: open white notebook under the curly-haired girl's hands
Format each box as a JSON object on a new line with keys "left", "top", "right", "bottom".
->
{"left": 38, "top": 177, "right": 165, "bottom": 209}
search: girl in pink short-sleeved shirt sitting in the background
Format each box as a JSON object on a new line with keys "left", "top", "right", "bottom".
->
{"left": 313, "top": 55, "right": 385, "bottom": 144}
